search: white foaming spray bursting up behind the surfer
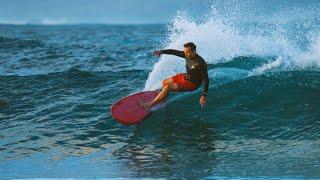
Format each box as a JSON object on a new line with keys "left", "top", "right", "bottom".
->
{"left": 144, "top": 11, "right": 320, "bottom": 90}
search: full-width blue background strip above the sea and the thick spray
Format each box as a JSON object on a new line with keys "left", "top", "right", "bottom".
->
{"left": 0, "top": 0, "right": 320, "bottom": 25}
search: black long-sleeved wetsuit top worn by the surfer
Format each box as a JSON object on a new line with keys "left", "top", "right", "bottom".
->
{"left": 160, "top": 49, "right": 209, "bottom": 96}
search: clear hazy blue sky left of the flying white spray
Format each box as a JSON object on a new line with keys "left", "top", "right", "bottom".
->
{"left": 0, "top": 0, "right": 210, "bottom": 24}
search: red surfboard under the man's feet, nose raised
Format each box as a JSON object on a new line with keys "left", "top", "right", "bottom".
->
{"left": 111, "top": 91, "right": 158, "bottom": 125}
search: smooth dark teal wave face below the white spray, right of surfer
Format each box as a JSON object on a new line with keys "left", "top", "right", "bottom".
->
{"left": 145, "top": 70, "right": 320, "bottom": 140}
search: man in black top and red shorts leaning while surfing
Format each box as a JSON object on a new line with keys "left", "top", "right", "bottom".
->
{"left": 138, "top": 42, "right": 209, "bottom": 110}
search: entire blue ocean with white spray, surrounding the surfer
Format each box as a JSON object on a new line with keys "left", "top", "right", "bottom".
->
{"left": 0, "top": 10, "right": 320, "bottom": 179}
